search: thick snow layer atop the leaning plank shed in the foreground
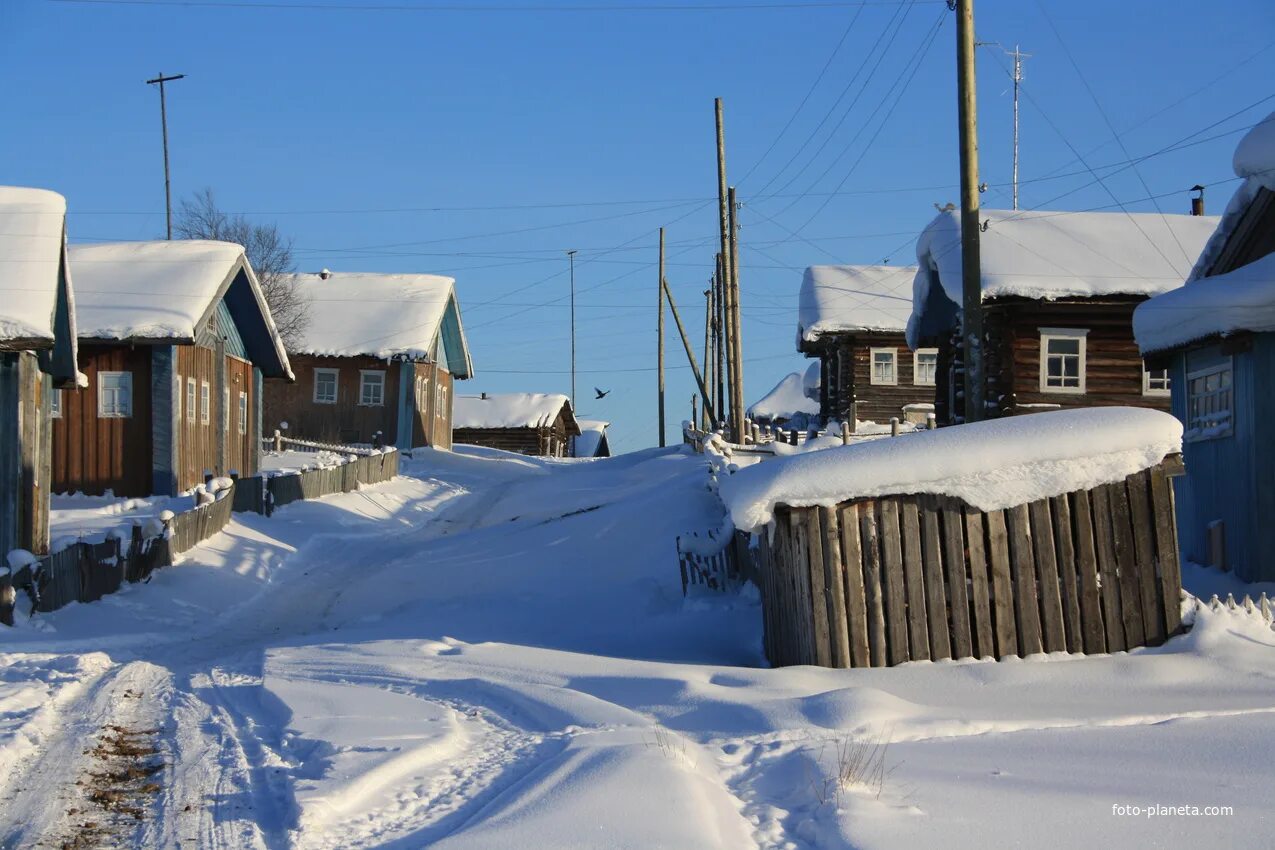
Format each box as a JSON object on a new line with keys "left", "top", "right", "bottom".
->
{"left": 719, "top": 408, "right": 1182, "bottom": 531}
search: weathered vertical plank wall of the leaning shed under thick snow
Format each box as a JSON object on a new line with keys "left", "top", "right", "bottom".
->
{"left": 759, "top": 456, "right": 1182, "bottom": 666}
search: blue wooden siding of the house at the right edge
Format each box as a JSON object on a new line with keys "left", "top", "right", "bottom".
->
{"left": 1172, "top": 334, "right": 1275, "bottom": 581}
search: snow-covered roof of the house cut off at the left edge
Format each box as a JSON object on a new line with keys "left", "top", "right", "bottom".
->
{"left": 0, "top": 186, "right": 66, "bottom": 340}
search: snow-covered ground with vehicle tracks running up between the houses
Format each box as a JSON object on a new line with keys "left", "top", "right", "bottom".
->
{"left": 0, "top": 450, "right": 1275, "bottom": 849}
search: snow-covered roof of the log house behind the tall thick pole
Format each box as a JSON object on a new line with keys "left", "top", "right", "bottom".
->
{"left": 908, "top": 209, "right": 1219, "bottom": 347}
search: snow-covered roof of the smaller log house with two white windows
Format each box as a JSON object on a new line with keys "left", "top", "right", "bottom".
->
{"left": 797, "top": 265, "right": 917, "bottom": 348}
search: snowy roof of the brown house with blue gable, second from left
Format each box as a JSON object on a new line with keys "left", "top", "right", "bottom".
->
{"left": 69, "top": 240, "right": 292, "bottom": 377}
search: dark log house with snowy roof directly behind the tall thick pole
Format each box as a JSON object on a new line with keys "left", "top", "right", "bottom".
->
{"left": 908, "top": 210, "right": 1218, "bottom": 424}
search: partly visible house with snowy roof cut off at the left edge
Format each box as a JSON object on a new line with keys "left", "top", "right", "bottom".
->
{"left": 0, "top": 186, "right": 77, "bottom": 563}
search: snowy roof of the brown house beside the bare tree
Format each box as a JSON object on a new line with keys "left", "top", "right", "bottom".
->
{"left": 293, "top": 271, "right": 473, "bottom": 378}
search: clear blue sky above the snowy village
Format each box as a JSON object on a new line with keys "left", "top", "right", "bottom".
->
{"left": 0, "top": 0, "right": 1275, "bottom": 450}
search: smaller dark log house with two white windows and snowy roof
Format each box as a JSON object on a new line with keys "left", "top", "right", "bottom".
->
{"left": 797, "top": 265, "right": 938, "bottom": 429}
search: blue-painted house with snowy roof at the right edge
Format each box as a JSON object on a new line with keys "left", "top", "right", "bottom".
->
{"left": 1133, "top": 115, "right": 1275, "bottom": 581}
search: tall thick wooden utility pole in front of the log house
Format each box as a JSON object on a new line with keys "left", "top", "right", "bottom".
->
{"left": 956, "top": 0, "right": 987, "bottom": 422}
